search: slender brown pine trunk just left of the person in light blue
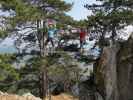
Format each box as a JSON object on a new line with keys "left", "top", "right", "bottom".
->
{"left": 37, "top": 20, "right": 48, "bottom": 100}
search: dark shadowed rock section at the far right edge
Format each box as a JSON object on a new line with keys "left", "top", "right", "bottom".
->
{"left": 117, "top": 35, "right": 133, "bottom": 100}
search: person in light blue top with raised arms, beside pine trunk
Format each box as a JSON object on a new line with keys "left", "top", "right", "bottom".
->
{"left": 45, "top": 24, "right": 57, "bottom": 47}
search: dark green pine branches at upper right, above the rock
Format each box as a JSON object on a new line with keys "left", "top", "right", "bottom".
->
{"left": 85, "top": 0, "right": 133, "bottom": 44}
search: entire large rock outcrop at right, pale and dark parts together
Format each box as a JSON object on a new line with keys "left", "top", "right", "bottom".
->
{"left": 94, "top": 35, "right": 133, "bottom": 100}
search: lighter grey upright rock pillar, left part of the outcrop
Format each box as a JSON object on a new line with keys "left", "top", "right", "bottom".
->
{"left": 95, "top": 45, "right": 119, "bottom": 100}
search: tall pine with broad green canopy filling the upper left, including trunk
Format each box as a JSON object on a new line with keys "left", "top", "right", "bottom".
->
{"left": 0, "top": 0, "right": 71, "bottom": 97}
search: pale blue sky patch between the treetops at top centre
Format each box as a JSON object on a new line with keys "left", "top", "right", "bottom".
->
{"left": 65, "top": 0, "right": 95, "bottom": 20}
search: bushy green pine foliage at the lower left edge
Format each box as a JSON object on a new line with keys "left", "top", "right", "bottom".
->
{"left": 0, "top": 54, "right": 20, "bottom": 92}
